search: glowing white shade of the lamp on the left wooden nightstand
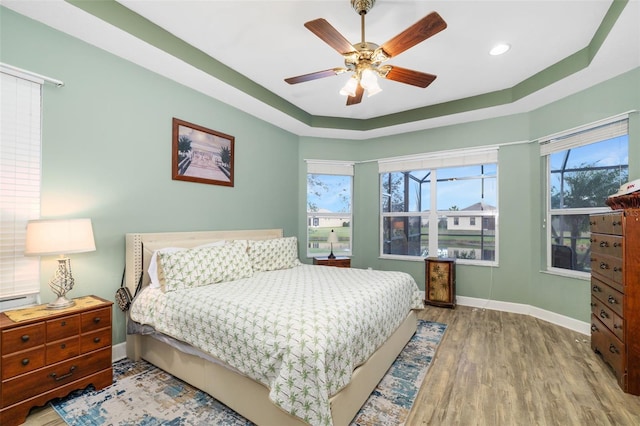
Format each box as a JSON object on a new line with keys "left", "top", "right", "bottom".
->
{"left": 24, "top": 219, "right": 96, "bottom": 256}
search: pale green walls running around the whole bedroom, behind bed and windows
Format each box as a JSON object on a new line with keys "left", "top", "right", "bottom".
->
{"left": 0, "top": 7, "right": 640, "bottom": 343}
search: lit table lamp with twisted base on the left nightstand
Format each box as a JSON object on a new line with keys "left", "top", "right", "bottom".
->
{"left": 24, "top": 219, "right": 96, "bottom": 309}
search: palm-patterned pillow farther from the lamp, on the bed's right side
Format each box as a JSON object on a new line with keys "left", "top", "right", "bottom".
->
{"left": 249, "top": 237, "right": 300, "bottom": 271}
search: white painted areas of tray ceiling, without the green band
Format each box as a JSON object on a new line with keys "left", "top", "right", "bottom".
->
{"left": 2, "top": 0, "right": 640, "bottom": 139}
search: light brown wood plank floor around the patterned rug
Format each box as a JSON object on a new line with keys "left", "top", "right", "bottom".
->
{"left": 26, "top": 306, "right": 640, "bottom": 426}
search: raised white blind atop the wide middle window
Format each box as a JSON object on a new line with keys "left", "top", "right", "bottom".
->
{"left": 378, "top": 147, "right": 498, "bottom": 173}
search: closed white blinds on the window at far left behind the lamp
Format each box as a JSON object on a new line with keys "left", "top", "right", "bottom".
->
{"left": 0, "top": 68, "right": 42, "bottom": 299}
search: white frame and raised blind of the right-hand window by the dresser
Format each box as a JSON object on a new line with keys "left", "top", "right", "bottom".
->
{"left": 538, "top": 113, "right": 629, "bottom": 280}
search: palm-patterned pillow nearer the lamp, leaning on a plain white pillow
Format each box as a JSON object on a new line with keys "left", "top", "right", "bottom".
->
{"left": 157, "top": 247, "right": 222, "bottom": 292}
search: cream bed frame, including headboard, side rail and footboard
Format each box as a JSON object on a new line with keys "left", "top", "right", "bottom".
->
{"left": 126, "top": 229, "right": 417, "bottom": 426}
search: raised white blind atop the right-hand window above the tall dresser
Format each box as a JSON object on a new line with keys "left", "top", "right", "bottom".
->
{"left": 540, "top": 115, "right": 629, "bottom": 156}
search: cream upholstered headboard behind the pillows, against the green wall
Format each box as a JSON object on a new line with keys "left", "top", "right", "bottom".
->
{"left": 125, "top": 229, "right": 283, "bottom": 294}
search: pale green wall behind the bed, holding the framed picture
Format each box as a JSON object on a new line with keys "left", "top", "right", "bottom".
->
{"left": 0, "top": 8, "right": 298, "bottom": 343}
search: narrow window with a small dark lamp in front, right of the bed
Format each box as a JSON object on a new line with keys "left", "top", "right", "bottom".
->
{"left": 307, "top": 160, "right": 353, "bottom": 257}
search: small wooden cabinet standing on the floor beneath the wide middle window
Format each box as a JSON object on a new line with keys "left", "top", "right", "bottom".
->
{"left": 424, "top": 257, "right": 456, "bottom": 308}
